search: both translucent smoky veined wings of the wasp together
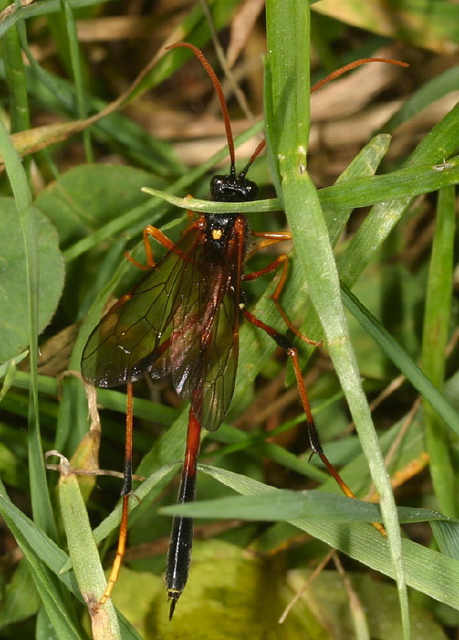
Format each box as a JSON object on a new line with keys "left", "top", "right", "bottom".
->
{"left": 82, "top": 223, "right": 242, "bottom": 430}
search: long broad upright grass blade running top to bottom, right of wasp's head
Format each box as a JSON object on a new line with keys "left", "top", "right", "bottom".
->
{"left": 266, "top": 0, "right": 410, "bottom": 639}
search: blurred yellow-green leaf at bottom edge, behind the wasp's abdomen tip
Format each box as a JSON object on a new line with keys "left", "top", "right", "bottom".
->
{"left": 142, "top": 541, "right": 332, "bottom": 640}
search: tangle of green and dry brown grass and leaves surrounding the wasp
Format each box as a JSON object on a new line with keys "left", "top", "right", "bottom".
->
{"left": 0, "top": 0, "right": 459, "bottom": 640}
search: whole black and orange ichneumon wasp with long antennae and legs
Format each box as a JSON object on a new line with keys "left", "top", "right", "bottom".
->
{"left": 81, "top": 42, "right": 408, "bottom": 618}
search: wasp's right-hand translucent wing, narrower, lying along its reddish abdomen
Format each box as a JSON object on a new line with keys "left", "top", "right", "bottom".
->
{"left": 151, "top": 219, "right": 245, "bottom": 431}
